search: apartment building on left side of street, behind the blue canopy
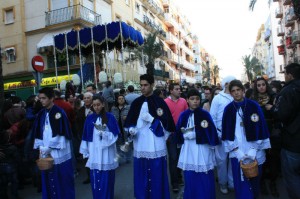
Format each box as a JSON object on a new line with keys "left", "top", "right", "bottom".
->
{"left": 0, "top": 0, "right": 206, "bottom": 98}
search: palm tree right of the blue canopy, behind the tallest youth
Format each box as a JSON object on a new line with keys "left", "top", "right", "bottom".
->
{"left": 131, "top": 32, "right": 163, "bottom": 75}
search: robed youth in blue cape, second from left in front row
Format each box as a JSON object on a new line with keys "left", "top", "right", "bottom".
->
{"left": 80, "top": 95, "right": 120, "bottom": 199}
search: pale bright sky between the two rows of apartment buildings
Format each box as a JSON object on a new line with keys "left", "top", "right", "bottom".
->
{"left": 176, "top": 0, "right": 269, "bottom": 79}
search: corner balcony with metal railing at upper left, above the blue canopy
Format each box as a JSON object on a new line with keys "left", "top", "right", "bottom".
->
{"left": 46, "top": 5, "right": 101, "bottom": 26}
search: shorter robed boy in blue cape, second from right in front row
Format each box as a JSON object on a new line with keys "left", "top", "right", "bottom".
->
{"left": 176, "top": 89, "right": 219, "bottom": 199}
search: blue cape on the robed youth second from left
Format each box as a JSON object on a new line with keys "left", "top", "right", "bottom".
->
{"left": 82, "top": 112, "right": 120, "bottom": 142}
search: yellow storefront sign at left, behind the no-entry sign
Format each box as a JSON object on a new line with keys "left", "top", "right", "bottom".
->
{"left": 4, "top": 75, "right": 73, "bottom": 90}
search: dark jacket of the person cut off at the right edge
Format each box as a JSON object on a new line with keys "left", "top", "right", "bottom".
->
{"left": 274, "top": 79, "right": 300, "bottom": 153}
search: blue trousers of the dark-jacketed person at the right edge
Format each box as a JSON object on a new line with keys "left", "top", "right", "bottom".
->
{"left": 281, "top": 149, "right": 300, "bottom": 199}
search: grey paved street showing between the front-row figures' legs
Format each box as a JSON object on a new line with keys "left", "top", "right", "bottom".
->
{"left": 20, "top": 160, "right": 288, "bottom": 199}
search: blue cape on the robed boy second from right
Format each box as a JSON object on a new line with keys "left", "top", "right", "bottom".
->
{"left": 176, "top": 107, "right": 219, "bottom": 146}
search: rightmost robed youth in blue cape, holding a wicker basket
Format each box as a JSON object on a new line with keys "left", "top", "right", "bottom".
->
{"left": 222, "top": 80, "right": 271, "bottom": 199}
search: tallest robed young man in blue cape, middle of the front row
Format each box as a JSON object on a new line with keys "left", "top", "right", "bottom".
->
{"left": 124, "top": 74, "right": 175, "bottom": 199}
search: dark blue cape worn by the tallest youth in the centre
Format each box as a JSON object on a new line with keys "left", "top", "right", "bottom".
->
{"left": 124, "top": 95, "right": 175, "bottom": 136}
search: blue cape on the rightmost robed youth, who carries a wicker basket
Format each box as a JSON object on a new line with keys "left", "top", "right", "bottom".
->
{"left": 222, "top": 98, "right": 269, "bottom": 141}
